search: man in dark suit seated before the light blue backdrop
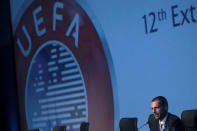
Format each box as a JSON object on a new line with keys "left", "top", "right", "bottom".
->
{"left": 148, "top": 96, "right": 184, "bottom": 131}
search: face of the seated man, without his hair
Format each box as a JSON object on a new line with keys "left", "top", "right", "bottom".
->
{"left": 151, "top": 100, "right": 167, "bottom": 120}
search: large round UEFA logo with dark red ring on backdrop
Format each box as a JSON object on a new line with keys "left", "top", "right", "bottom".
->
{"left": 14, "top": 0, "right": 118, "bottom": 131}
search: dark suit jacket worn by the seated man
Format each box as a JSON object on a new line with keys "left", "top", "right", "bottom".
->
{"left": 148, "top": 113, "right": 184, "bottom": 131}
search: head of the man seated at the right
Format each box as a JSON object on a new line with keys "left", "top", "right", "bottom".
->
{"left": 151, "top": 96, "right": 168, "bottom": 120}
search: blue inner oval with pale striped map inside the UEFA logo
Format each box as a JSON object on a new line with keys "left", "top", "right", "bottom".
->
{"left": 26, "top": 40, "right": 88, "bottom": 130}
